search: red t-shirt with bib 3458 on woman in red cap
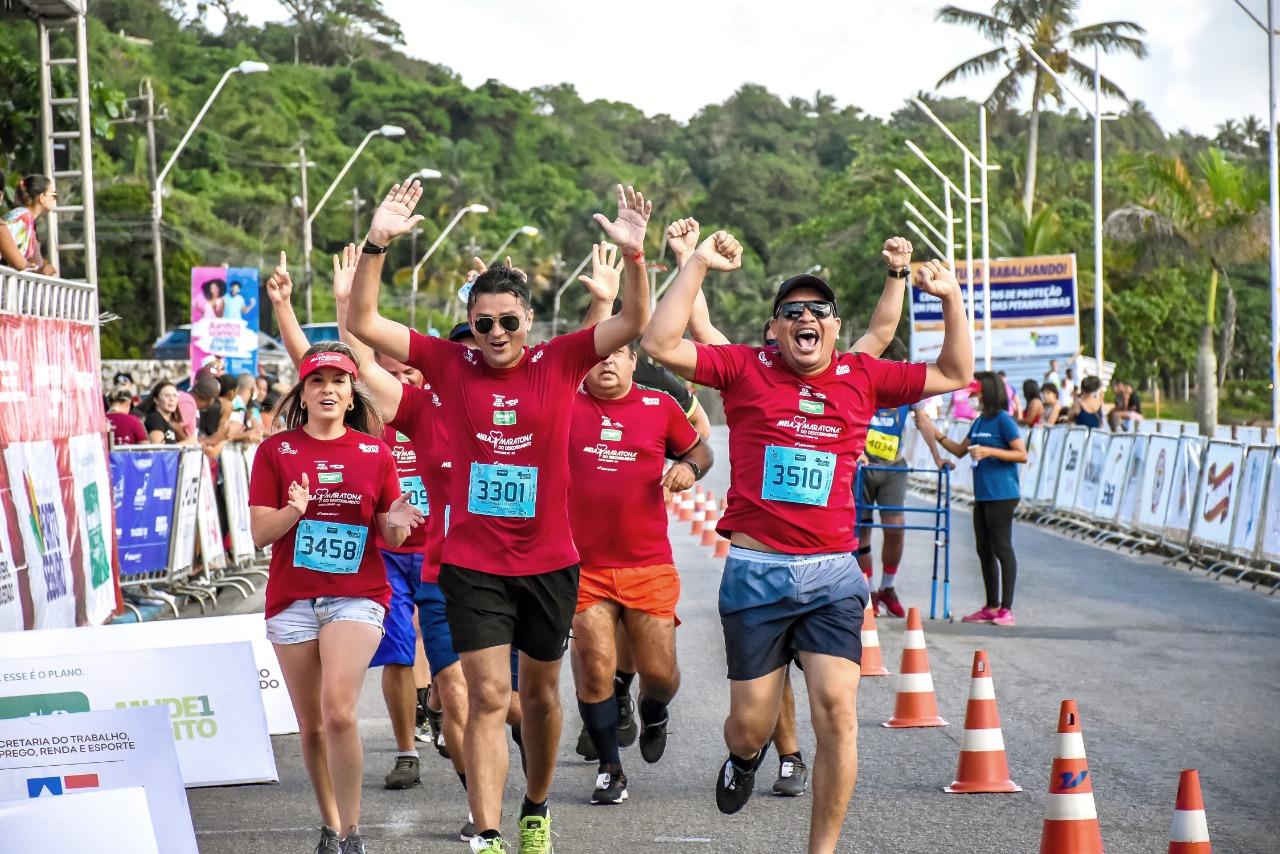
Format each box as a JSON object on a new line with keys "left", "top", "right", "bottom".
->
{"left": 248, "top": 428, "right": 401, "bottom": 617}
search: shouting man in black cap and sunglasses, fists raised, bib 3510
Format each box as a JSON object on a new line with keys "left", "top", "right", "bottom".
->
{"left": 641, "top": 232, "right": 973, "bottom": 854}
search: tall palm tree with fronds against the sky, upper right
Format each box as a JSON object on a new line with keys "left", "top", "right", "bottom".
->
{"left": 937, "top": 0, "right": 1147, "bottom": 222}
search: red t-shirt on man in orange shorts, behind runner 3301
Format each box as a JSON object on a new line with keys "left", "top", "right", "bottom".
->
{"left": 568, "top": 385, "right": 698, "bottom": 570}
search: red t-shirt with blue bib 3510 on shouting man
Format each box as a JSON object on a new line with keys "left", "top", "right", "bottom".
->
{"left": 694, "top": 344, "right": 925, "bottom": 554}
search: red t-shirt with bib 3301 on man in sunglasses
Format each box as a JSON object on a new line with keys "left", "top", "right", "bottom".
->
{"left": 409, "top": 328, "right": 600, "bottom": 575}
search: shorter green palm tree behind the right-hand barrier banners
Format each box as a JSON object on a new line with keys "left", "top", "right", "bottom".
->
{"left": 1106, "top": 149, "right": 1270, "bottom": 435}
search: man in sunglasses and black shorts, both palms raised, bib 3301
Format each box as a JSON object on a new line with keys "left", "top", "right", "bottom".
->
{"left": 347, "top": 181, "right": 653, "bottom": 854}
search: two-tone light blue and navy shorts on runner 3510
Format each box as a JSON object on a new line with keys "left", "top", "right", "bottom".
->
{"left": 719, "top": 545, "right": 870, "bottom": 681}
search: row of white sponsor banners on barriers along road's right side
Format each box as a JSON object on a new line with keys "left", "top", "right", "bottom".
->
{"left": 908, "top": 419, "right": 1280, "bottom": 593}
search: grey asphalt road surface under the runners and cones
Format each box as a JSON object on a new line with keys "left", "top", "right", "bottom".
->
{"left": 188, "top": 429, "right": 1280, "bottom": 854}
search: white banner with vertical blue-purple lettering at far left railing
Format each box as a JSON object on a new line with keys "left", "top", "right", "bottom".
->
{"left": 4, "top": 442, "right": 76, "bottom": 629}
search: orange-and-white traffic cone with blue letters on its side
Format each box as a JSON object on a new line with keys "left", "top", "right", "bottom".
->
{"left": 1041, "top": 700, "right": 1102, "bottom": 854}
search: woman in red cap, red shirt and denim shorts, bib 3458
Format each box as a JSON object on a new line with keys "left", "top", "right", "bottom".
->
{"left": 248, "top": 342, "right": 422, "bottom": 854}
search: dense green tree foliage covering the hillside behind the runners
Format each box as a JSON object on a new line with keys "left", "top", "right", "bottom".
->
{"left": 0, "top": 0, "right": 1268, "bottom": 414}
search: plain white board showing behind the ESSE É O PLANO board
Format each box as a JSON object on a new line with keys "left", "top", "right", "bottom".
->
{"left": 0, "top": 613, "right": 298, "bottom": 735}
